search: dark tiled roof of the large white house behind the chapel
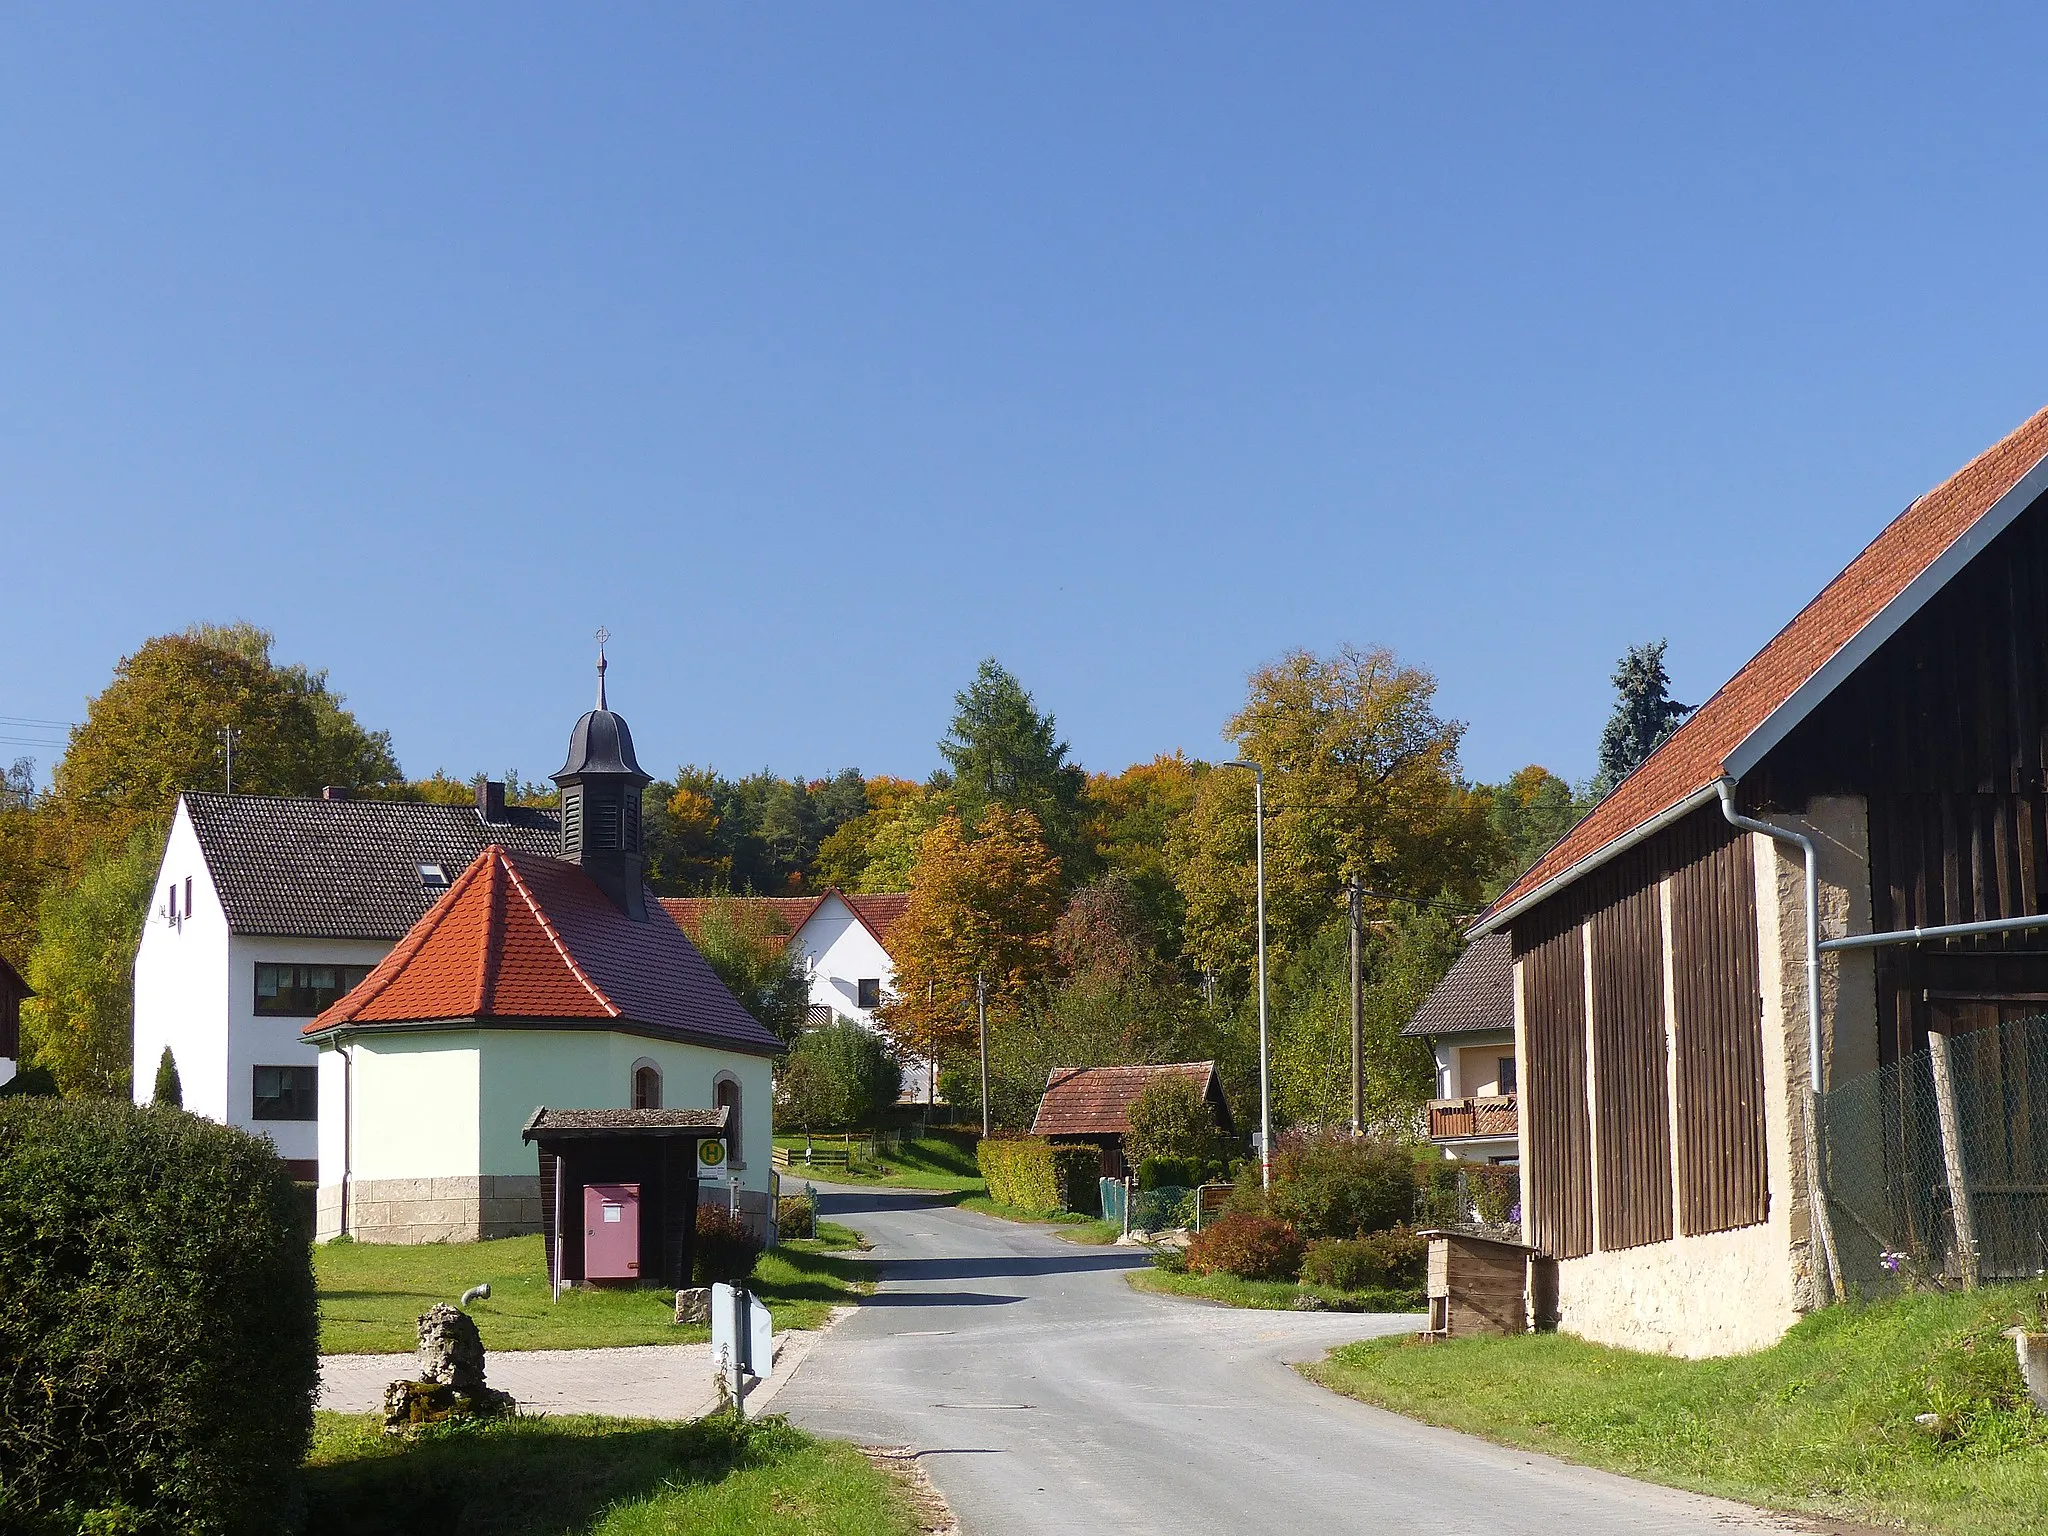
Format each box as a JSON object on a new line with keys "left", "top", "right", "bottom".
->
{"left": 184, "top": 793, "right": 561, "bottom": 938}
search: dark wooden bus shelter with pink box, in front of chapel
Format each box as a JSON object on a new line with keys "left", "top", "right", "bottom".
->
{"left": 520, "top": 1106, "right": 727, "bottom": 1290}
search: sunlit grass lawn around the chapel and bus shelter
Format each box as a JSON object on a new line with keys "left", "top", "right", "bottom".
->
{"left": 313, "top": 1221, "right": 870, "bottom": 1354}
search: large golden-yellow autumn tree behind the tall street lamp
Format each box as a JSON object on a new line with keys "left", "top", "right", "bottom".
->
{"left": 1176, "top": 647, "right": 1493, "bottom": 979}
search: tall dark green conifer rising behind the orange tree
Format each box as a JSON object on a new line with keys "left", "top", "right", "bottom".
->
{"left": 938, "top": 657, "right": 1094, "bottom": 877}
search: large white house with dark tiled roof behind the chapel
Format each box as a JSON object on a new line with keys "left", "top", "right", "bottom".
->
{"left": 133, "top": 784, "right": 559, "bottom": 1182}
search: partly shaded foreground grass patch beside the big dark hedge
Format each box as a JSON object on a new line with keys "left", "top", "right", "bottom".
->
{"left": 305, "top": 1413, "right": 918, "bottom": 1536}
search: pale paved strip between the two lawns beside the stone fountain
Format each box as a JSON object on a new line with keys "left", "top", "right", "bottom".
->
{"left": 319, "top": 1329, "right": 821, "bottom": 1419}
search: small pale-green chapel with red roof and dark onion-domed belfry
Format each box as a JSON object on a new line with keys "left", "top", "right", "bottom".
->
{"left": 303, "top": 666, "right": 782, "bottom": 1243}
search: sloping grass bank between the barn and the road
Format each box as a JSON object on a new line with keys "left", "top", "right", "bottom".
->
{"left": 1307, "top": 1284, "right": 2048, "bottom": 1536}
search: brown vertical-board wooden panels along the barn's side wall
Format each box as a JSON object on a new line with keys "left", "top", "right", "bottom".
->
{"left": 1513, "top": 807, "right": 1769, "bottom": 1260}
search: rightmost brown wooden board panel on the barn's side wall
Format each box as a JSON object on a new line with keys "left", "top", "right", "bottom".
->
{"left": 1671, "top": 821, "right": 1769, "bottom": 1237}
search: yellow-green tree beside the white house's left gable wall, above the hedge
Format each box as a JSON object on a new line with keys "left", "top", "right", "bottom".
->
{"left": 20, "top": 825, "right": 164, "bottom": 1098}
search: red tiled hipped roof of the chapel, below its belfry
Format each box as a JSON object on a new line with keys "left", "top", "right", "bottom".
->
{"left": 305, "top": 844, "right": 782, "bottom": 1055}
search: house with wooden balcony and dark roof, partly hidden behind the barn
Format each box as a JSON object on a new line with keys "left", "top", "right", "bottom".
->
{"left": 1401, "top": 934, "right": 1522, "bottom": 1163}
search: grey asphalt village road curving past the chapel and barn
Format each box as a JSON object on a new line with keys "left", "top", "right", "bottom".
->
{"left": 776, "top": 1190, "right": 1815, "bottom": 1536}
